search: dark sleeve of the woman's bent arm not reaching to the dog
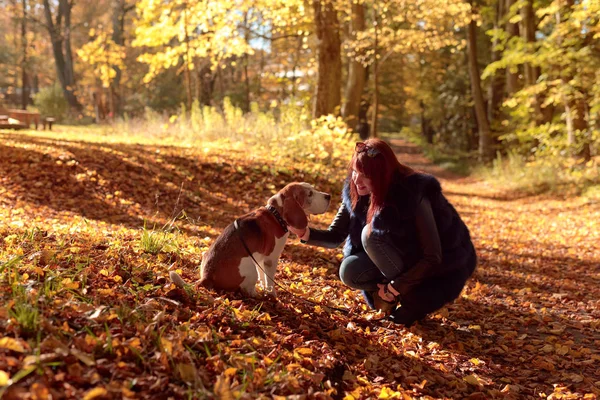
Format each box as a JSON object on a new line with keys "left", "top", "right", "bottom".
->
{"left": 392, "top": 198, "right": 442, "bottom": 293}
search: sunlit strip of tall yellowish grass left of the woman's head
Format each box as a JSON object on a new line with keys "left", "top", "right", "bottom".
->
{"left": 105, "top": 98, "right": 353, "bottom": 173}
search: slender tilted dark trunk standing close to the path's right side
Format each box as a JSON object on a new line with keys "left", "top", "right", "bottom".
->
{"left": 467, "top": 7, "right": 493, "bottom": 161}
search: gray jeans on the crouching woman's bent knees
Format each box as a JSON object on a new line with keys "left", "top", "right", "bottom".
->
{"left": 340, "top": 225, "right": 404, "bottom": 291}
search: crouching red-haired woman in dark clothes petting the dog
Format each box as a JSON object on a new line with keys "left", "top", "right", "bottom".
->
{"left": 295, "top": 139, "right": 477, "bottom": 326}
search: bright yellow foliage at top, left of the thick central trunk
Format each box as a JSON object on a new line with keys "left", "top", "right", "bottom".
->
{"left": 133, "top": 0, "right": 314, "bottom": 83}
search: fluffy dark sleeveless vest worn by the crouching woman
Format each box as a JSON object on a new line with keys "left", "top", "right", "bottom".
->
{"left": 342, "top": 173, "right": 476, "bottom": 275}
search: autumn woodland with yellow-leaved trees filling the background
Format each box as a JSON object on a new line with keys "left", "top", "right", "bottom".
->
{"left": 0, "top": 0, "right": 600, "bottom": 189}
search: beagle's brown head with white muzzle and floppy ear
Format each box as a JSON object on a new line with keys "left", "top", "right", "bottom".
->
{"left": 274, "top": 182, "right": 331, "bottom": 229}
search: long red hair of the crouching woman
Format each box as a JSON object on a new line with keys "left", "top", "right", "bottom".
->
{"left": 348, "top": 139, "right": 415, "bottom": 223}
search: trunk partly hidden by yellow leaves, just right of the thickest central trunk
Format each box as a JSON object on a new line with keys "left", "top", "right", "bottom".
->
{"left": 342, "top": 3, "right": 367, "bottom": 129}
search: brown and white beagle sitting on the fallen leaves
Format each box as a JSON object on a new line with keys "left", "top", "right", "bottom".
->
{"left": 170, "top": 182, "right": 331, "bottom": 297}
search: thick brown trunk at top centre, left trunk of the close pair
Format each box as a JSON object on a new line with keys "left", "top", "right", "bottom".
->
{"left": 313, "top": 0, "right": 342, "bottom": 118}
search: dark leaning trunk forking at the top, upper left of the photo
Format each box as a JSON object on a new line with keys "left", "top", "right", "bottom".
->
{"left": 43, "top": 0, "right": 83, "bottom": 112}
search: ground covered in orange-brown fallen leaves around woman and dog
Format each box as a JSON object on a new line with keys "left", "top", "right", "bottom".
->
{"left": 0, "top": 131, "right": 600, "bottom": 399}
